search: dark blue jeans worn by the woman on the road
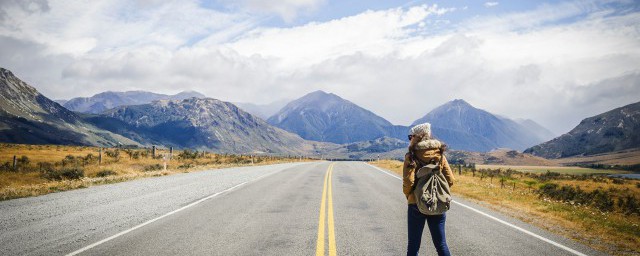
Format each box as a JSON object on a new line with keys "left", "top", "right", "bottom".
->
{"left": 407, "top": 204, "right": 451, "bottom": 256}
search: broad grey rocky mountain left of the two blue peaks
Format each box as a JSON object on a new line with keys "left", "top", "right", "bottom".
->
{"left": 94, "top": 98, "right": 331, "bottom": 154}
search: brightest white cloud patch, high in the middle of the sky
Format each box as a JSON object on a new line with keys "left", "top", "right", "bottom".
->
{"left": 222, "top": 5, "right": 449, "bottom": 70}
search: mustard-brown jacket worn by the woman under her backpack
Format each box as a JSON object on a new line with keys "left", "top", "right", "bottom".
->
{"left": 402, "top": 140, "right": 456, "bottom": 204}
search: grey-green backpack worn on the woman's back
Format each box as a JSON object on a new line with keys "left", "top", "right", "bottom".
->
{"left": 413, "top": 148, "right": 452, "bottom": 215}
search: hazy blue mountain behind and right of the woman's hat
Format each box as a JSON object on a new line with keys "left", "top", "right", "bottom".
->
{"left": 413, "top": 99, "right": 546, "bottom": 152}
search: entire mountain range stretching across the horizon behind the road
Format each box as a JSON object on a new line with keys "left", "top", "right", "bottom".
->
{"left": 0, "top": 68, "right": 640, "bottom": 159}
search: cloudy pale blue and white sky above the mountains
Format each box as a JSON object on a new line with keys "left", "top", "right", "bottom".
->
{"left": 0, "top": 0, "right": 640, "bottom": 134}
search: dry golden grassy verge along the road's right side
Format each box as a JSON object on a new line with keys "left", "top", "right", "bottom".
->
{"left": 372, "top": 160, "right": 640, "bottom": 255}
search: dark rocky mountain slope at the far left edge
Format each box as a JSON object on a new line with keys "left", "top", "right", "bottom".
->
{"left": 0, "top": 68, "right": 139, "bottom": 146}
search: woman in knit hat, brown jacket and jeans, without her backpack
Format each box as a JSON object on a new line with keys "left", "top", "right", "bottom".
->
{"left": 402, "top": 123, "right": 455, "bottom": 256}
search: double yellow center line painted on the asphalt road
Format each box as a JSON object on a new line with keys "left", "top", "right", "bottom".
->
{"left": 316, "top": 163, "right": 336, "bottom": 256}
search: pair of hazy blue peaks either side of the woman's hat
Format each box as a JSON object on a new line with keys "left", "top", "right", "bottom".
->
{"left": 267, "top": 91, "right": 553, "bottom": 152}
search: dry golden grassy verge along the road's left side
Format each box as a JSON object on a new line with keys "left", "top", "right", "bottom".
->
{"left": 0, "top": 144, "right": 306, "bottom": 201}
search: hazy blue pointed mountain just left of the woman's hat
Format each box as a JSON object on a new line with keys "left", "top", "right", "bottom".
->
{"left": 267, "top": 91, "right": 407, "bottom": 144}
